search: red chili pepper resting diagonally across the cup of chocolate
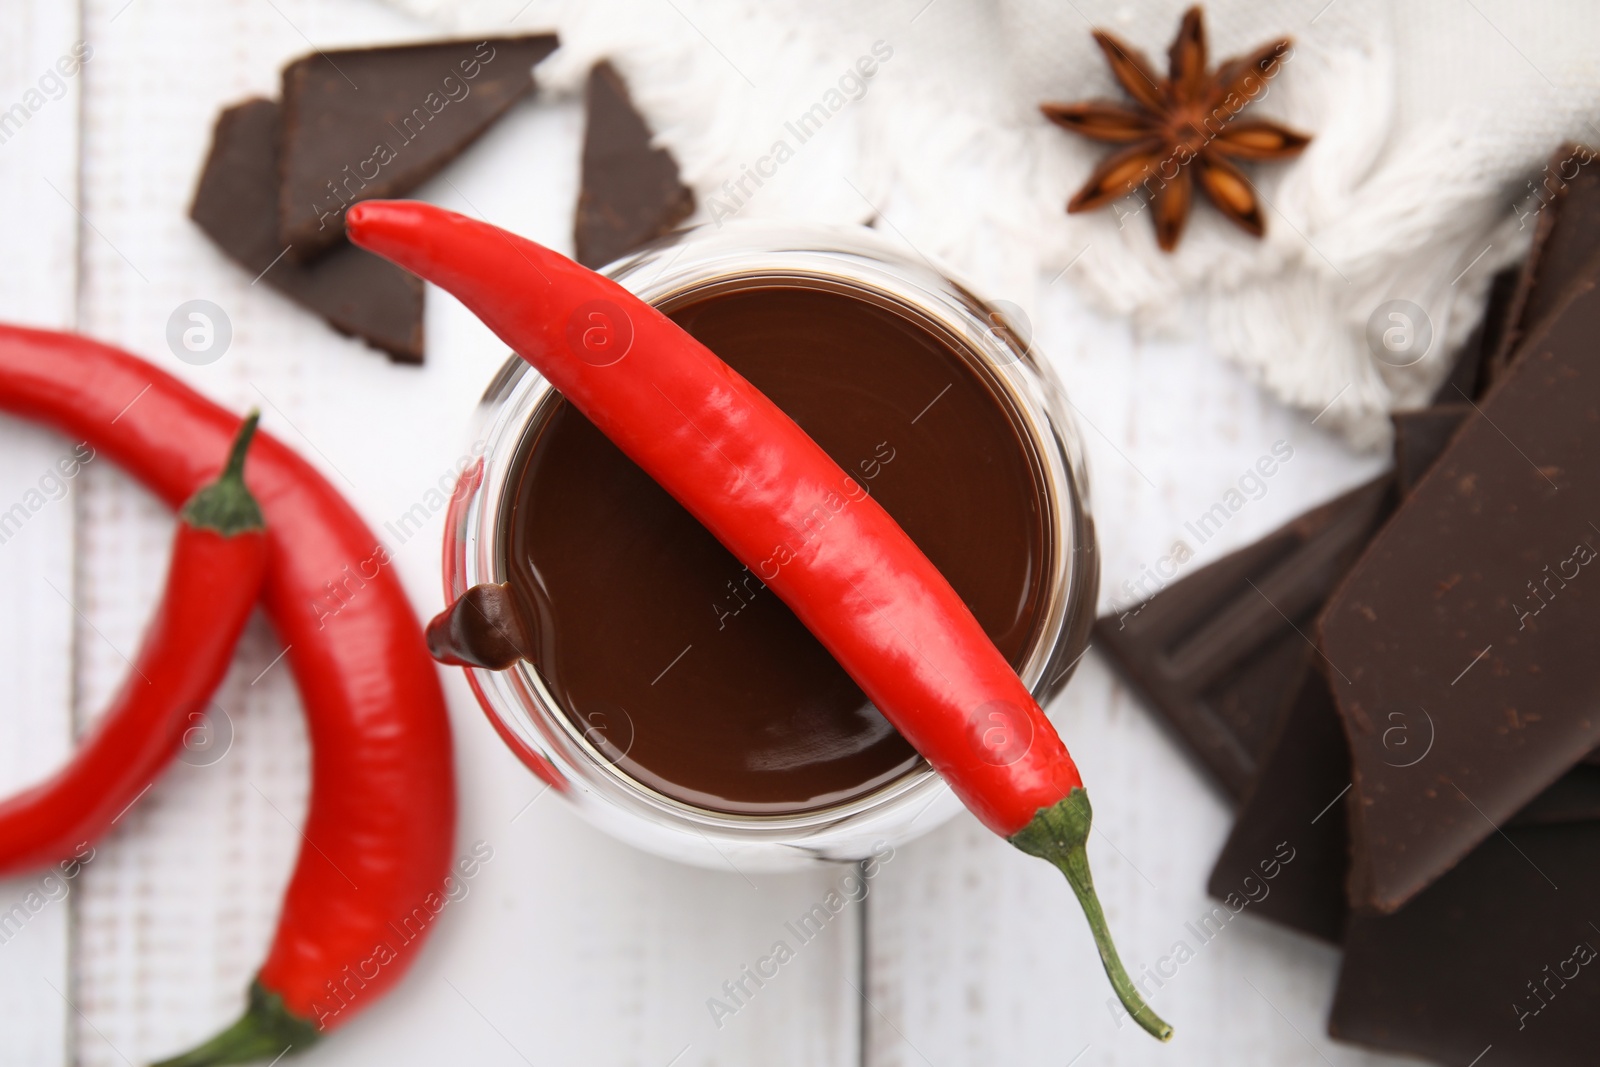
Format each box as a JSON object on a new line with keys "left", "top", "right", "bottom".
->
{"left": 346, "top": 200, "right": 1171, "bottom": 1040}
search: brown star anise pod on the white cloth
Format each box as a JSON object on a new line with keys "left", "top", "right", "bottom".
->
{"left": 1040, "top": 6, "right": 1310, "bottom": 251}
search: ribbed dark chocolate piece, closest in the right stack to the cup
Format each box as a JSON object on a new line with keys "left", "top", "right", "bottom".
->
{"left": 1094, "top": 475, "right": 1394, "bottom": 798}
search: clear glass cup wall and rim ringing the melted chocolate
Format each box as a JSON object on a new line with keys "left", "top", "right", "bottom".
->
{"left": 443, "top": 222, "right": 1099, "bottom": 870}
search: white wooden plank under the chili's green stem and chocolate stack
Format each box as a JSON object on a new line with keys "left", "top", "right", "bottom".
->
{"left": 866, "top": 279, "right": 1402, "bottom": 1067}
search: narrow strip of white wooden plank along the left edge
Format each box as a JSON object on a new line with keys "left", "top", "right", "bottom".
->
{"left": 0, "top": 0, "right": 82, "bottom": 1067}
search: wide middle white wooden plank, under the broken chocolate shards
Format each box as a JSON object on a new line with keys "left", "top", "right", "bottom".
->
{"left": 75, "top": 0, "right": 859, "bottom": 1067}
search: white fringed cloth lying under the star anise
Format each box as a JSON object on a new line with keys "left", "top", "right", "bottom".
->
{"left": 377, "top": 0, "right": 1600, "bottom": 446}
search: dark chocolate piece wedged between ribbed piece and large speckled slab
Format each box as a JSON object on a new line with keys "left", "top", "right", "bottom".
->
{"left": 1206, "top": 669, "right": 1350, "bottom": 944}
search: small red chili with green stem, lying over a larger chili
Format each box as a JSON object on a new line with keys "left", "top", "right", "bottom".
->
{"left": 0, "top": 411, "right": 267, "bottom": 875}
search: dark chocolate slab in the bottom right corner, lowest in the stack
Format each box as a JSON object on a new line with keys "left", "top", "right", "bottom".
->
{"left": 1324, "top": 822, "right": 1600, "bottom": 1067}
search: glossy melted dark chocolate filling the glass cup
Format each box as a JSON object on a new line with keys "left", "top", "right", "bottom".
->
{"left": 501, "top": 280, "right": 1050, "bottom": 814}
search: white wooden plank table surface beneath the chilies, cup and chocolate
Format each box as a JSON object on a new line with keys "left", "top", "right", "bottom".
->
{"left": 0, "top": 0, "right": 1414, "bottom": 1067}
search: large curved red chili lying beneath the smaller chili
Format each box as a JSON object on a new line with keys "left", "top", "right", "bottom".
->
{"left": 0, "top": 326, "right": 456, "bottom": 1067}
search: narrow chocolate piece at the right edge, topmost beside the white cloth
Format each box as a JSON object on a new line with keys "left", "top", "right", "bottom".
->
{"left": 1480, "top": 144, "right": 1600, "bottom": 392}
